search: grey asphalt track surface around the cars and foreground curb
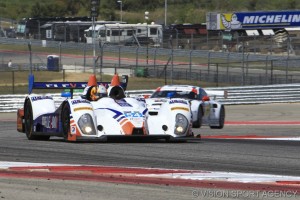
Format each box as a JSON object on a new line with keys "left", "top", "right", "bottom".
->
{"left": 0, "top": 104, "right": 300, "bottom": 199}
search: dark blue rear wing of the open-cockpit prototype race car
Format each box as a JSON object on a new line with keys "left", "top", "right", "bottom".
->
{"left": 28, "top": 74, "right": 128, "bottom": 98}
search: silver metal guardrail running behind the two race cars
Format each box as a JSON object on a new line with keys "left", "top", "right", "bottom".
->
{"left": 0, "top": 84, "right": 300, "bottom": 112}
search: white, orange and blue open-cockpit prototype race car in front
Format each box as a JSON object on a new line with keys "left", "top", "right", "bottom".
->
{"left": 17, "top": 75, "right": 191, "bottom": 141}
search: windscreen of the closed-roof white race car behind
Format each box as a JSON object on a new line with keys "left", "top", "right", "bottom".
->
{"left": 150, "top": 90, "right": 197, "bottom": 99}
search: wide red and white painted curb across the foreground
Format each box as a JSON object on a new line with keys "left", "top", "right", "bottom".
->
{"left": 0, "top": 161, "right": 300, "bottom": 194}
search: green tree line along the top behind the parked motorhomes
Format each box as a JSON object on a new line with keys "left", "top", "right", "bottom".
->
{"left": 0, "top": 0, "right": 300, "bottom": 23}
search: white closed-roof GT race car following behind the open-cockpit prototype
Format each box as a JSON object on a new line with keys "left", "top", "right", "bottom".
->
{"left": 146, "top": 85, "right": 225, "bottom": 129}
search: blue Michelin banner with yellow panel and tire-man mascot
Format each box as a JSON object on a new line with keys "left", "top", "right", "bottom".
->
{"left": 206, "top": 11, "right": 300, "bottom": 30}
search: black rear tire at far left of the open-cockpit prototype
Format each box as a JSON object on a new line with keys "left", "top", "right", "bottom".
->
{"left": 24, "top": 100, "right": 50, "bottom": 140}
